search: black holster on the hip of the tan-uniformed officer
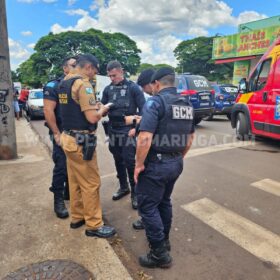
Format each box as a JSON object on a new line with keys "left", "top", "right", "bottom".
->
{"left": 76, "top": 133, "right": 97, "bottom": 160}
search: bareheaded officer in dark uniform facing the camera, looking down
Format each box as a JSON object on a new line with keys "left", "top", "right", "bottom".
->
{"left": 101, "top": 61, "right": 145, "bottom": 209}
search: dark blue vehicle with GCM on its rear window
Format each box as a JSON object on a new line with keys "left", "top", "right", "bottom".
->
{"left": 176, "top": 74, "right": 215, "bottom": 124}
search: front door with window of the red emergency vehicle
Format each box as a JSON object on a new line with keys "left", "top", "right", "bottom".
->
{"left": 248, "top": 58, "right": 273, "bottom": 135}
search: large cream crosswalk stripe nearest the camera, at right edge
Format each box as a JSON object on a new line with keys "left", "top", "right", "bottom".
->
{"left": 181, "top": 198, "right": 280, "bottom": 268}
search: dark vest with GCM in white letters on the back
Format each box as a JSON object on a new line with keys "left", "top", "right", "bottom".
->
{"left": 151, "top": 93, "right": 194, "bottom": 153}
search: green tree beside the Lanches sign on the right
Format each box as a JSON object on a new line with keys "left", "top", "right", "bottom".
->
{"left": 174, "top": 37, "right": 233, "bottom": 82}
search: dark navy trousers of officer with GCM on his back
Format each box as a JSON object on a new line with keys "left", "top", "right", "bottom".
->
{"left": 136, "top": 156, "right": 183, "bottom": 246}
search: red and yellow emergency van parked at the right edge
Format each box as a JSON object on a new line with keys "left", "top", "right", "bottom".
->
{"left": 231, "top": 37, "right": 280, "bottom": 140}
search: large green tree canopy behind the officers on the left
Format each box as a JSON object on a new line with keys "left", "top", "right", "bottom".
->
{"left": 17, "top": 29, "right": 141, "bottom": 86}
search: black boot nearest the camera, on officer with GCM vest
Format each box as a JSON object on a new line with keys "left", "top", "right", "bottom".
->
{"left": 139, "top": 241, "right": 172, "bottom": 268}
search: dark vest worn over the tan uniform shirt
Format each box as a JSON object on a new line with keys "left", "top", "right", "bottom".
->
{"left": 58, "top": 77, "right": 97, "bottom": 131}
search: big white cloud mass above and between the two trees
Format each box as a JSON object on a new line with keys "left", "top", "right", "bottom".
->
{"left": 51, "top": 0, "right": 265, "bottom": 65}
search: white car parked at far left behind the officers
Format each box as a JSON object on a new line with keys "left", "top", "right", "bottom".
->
{"left": 25, "top": 89, "right": 44, "bottom": 120}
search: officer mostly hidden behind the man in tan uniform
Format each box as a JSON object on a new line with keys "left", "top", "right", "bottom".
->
{"left": 43, "top": 57, "right": 76, "bottom": 219}
